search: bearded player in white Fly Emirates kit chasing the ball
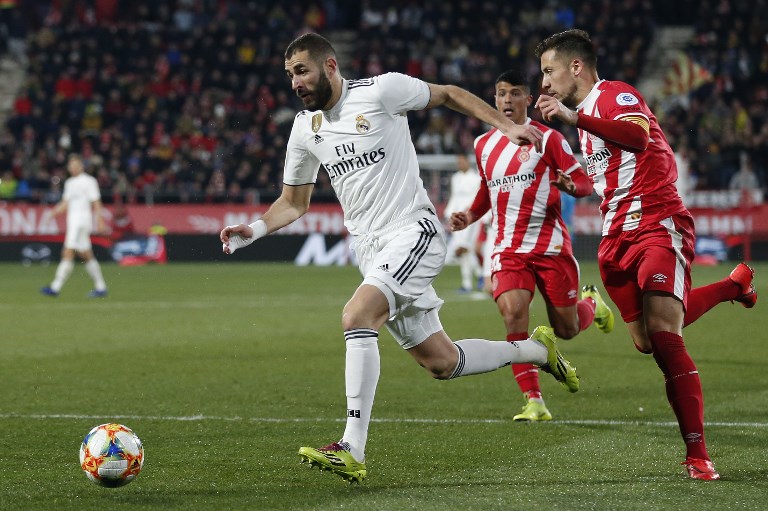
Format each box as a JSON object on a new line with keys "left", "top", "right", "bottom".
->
{"left": 220, "top": 33, "right": 579, "bottom": 482}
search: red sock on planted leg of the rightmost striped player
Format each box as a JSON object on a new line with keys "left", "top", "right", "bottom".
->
{"left": 650, "top": 332, "right": 709, "bottom": 460}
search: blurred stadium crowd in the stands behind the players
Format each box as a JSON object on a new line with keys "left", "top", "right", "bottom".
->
{"left": 0, "top": 0, "right": 768, "bottom": 203}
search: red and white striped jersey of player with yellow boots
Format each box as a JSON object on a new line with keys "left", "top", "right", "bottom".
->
{"left": 475, "top": 119, "right": 583, "bottom": 255}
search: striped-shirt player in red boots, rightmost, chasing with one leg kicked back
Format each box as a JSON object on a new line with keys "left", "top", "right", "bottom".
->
{"left": 536, "top": 29, "right": 757, "bottom": 480}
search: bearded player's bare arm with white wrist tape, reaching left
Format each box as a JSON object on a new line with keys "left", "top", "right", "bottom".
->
{"left": 219, "top": 183, "right": 315, "bottom": 254}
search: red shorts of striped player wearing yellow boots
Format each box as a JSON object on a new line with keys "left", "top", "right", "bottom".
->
{"left": 491, "top": 252, "right": 579, "bottom": 307}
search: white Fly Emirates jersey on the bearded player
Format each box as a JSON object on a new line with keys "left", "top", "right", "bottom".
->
{"left": 283, "top": 73, "right": 434, "bottom": 235}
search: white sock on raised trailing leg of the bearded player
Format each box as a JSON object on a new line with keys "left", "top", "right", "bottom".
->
{"left": 451, "top": 339, "right": 547, "bottom": 378}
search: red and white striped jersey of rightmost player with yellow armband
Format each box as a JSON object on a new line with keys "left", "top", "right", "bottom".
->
{"left": 576, "top": 80, "right": 685, "bottom": 236}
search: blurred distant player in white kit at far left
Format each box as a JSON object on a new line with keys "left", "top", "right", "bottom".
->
{"left": 40, "top": 154, "right": 107, "bottom": 298}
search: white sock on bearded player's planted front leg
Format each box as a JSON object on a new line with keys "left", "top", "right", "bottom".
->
{"left": 342, "top": 328, "right": 381, "bottom": 463}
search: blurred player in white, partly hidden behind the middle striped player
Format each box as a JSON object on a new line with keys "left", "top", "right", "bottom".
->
{"left": 443, "top": 154, "right": 480, "bottom": 292}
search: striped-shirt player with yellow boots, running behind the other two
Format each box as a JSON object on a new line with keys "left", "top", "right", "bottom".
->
{"left": 449, "top": 70, "right": 614, "bottom": 421}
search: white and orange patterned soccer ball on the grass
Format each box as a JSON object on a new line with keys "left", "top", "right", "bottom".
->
{"left": 80, "top": 424, "right": 144, "bottom": 488}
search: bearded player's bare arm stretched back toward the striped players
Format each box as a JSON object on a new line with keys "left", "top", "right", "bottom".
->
{"left": 427, "top": 83, "right": 544, "bottom": 152}
